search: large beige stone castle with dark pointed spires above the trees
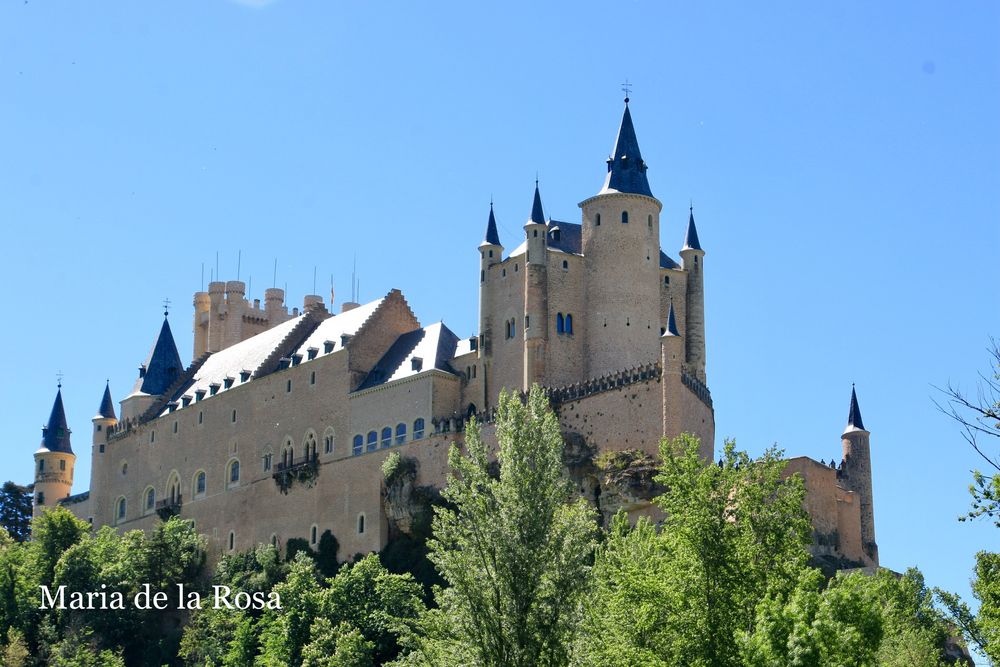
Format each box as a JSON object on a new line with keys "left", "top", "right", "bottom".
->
{"left": 34, "top": 98, "right": 878, "bottom": 568}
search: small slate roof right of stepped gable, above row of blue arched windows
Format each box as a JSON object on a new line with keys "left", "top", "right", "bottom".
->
{"left": 358, "top": 322, "right": 458, "bottom": 391}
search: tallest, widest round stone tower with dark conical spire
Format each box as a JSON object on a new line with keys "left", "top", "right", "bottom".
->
{"left": 580, "top": 98, "right": 662, "bottom": 377}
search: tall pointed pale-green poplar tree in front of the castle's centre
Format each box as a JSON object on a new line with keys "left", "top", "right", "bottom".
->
{"left": 409, "top": 386, "right": 596, "bottom": 667}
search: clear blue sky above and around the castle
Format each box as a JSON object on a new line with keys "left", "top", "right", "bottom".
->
{"left": 0, "top": 0, "right": 1000, "bottom": 628}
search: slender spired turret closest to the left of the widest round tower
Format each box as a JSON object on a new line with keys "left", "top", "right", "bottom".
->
{"left": 522, "top": 180, "right": 549, "bottom": 391}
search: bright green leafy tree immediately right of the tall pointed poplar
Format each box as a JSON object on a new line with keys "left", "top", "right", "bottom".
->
{"left": 578, "top": 434, "right": 811, "bottom": 667}
